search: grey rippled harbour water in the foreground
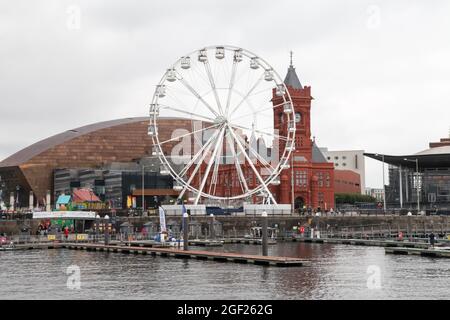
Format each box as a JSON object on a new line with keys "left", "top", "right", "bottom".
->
{"left": 0, "top": 243, "right": 450, "bottom": 299}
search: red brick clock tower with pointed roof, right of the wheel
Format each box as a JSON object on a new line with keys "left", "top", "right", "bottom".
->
{"left": 273, "top": 64, "right": 335, "bottom": 210}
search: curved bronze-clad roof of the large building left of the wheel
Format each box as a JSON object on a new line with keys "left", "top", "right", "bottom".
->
{"left": 0, "top": 117, "right": 191, "bottom": 204}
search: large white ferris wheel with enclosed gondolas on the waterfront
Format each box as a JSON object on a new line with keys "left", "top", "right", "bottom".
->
{"left": 148, "top": 46, "right": 295, "bottom": 204}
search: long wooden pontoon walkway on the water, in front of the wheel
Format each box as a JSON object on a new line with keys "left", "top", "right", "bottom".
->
{"left": 61, "top": 243, "right": 309, "bottom": 267}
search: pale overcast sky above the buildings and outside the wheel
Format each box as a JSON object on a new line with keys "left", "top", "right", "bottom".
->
{"left": 0, "top": 0, "right": 450, "bottom": 187}
